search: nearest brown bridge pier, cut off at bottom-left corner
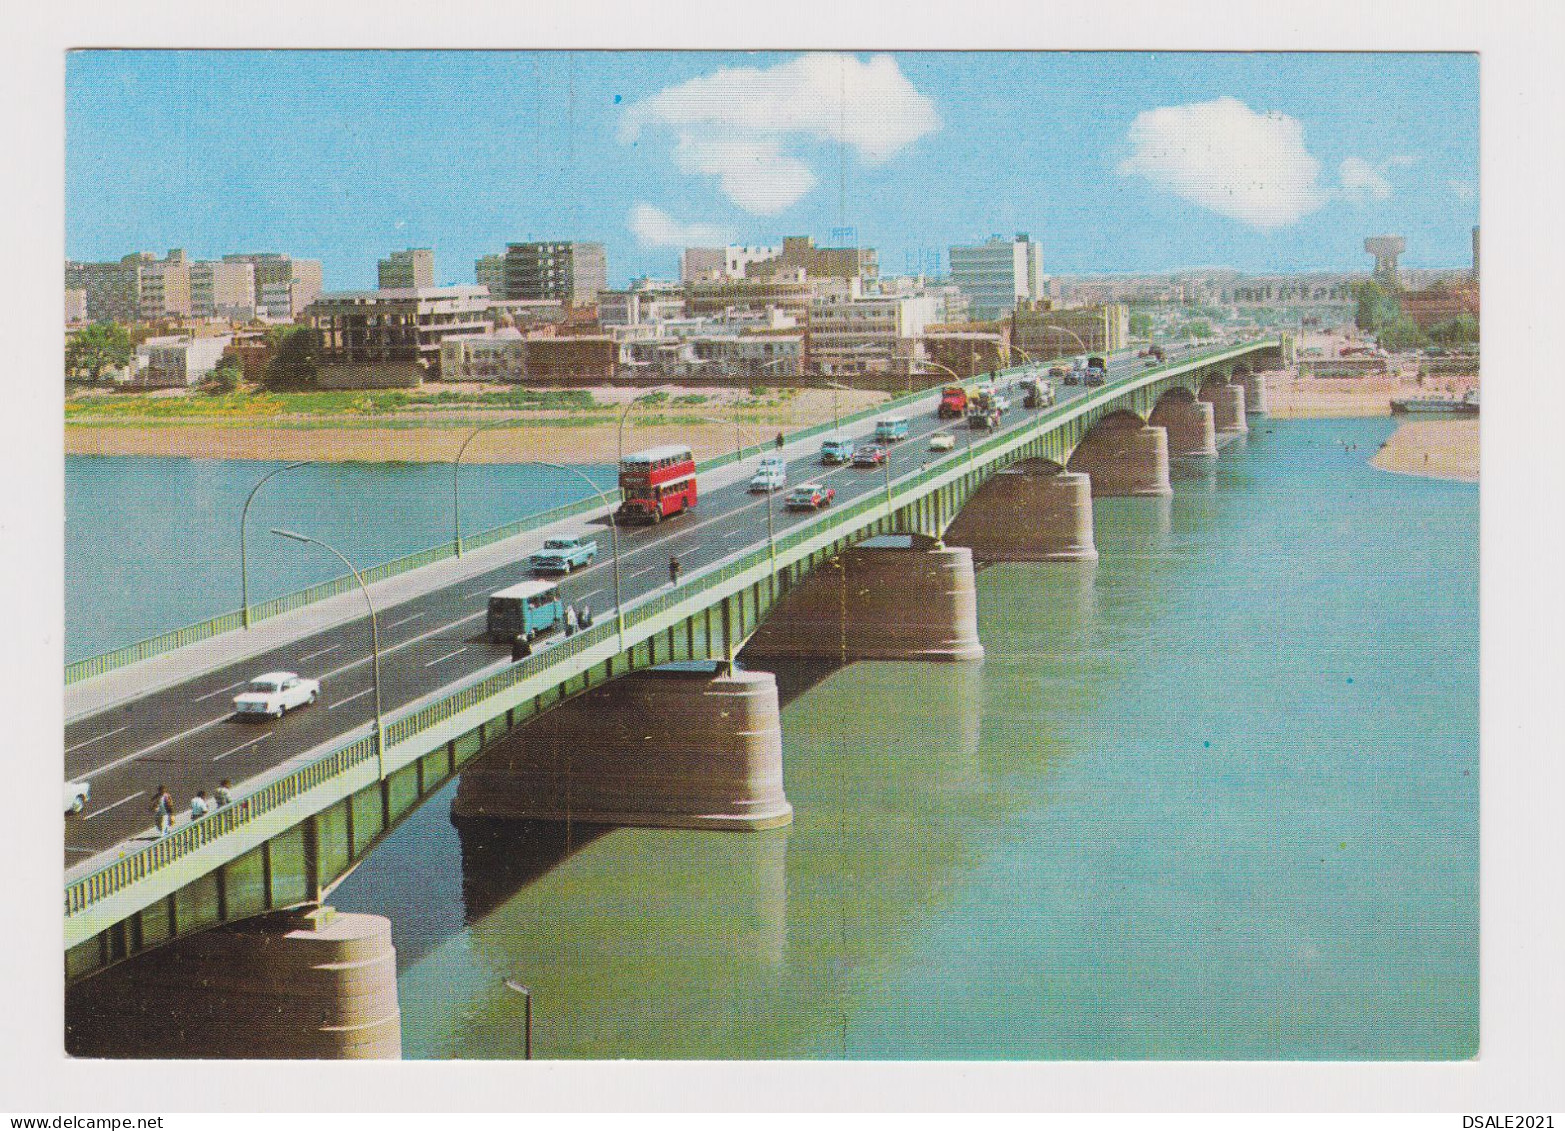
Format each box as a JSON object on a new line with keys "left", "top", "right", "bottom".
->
{"left": 66, "top": 907, "right": 402, "bottom": 1061}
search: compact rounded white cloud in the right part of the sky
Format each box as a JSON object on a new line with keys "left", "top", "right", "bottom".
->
{"left": 1119, "top": 99, "right": 1327, "bottom": 228}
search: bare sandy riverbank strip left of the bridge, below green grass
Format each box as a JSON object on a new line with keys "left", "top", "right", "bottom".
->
{"left": 66, "top": 390, "right": 886, "bottom": 463}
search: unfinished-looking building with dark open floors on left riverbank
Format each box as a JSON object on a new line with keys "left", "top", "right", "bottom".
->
{"left": 305, "top": 286, "right": 491, "bottom": 388}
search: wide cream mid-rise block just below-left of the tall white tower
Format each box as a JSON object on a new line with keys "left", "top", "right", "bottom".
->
{"left": 809, "top": 293, "right": 939, "bottom": 374}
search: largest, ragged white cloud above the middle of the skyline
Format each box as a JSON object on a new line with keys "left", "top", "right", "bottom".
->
{"left": 620, "top": 55, "right": 941, "bottom": 216}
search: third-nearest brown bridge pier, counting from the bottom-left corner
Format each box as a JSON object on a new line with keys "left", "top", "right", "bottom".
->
{"left": 743, "top": 535, "right": 983, "bottom": 663}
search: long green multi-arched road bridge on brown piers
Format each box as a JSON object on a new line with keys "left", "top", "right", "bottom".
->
{"left": 64, "top": 338, "right": 1291, "bottom": 1056}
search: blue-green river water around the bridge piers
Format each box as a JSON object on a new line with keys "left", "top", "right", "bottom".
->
{"left": 67, "top": 419, "right": 1479, "bottom": 1059}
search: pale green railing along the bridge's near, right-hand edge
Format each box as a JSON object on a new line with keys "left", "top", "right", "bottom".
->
{"left": 66, "top": 342, "right": 1277, "bottom": 915}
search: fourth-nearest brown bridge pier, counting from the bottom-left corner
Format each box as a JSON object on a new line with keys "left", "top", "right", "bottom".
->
{"left": 945, "top": 460, "right": 1097, "bottom": 562}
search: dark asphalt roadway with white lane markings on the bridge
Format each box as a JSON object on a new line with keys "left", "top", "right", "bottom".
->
{"left": 64, "top": 352, "right": 1175, "bottom": 868}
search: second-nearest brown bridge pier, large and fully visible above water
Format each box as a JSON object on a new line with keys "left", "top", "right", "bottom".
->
{"left": 452, "top": 665, "right": 793, "bottom": 829}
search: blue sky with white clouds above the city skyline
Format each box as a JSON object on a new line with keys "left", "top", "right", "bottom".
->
{"left": 66, "top": 52, "right": 1479, "bottom": 289}
